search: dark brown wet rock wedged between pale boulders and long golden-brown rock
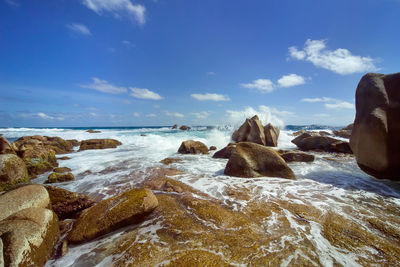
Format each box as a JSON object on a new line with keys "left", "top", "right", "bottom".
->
{"left": 46, "top": 186, "right": 96, "bottom": 220}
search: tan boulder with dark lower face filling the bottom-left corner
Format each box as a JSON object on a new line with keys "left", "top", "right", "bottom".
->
{"left": 0, "top": 207, "right": 59, "bottom": 266}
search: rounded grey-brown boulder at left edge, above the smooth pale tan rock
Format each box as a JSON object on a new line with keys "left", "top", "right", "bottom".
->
{"left": 0, "top": 154, "right": 29, "bottom": 191}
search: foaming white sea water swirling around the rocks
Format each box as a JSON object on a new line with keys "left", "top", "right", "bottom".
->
{"left": 0, "top": 125, "right": 400, "bottom": 267}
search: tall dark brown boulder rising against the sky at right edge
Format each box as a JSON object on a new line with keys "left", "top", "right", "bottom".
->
{"left": 350, "top": 73, "right": 400, "bottom": 180}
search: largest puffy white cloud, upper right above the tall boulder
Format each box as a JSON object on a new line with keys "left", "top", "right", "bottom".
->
{"left": 289, "top": 39, "right": 378, "bottom": 75}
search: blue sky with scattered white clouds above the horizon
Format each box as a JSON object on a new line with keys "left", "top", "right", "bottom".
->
{"left": 0, "top": 0, "right": 400, "bottom": 127}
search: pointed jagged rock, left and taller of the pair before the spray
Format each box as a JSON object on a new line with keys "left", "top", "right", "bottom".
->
{"left": 232, "top": 115, "right": 265, "bottom": 146}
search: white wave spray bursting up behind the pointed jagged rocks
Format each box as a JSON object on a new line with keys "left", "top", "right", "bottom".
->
{"left": 226, "top": 105, "right": 294, "bottom": 128}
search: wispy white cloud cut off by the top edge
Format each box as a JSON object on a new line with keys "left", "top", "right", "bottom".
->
{"left": 83, "top": 0, "right": 146, "bottom": 24}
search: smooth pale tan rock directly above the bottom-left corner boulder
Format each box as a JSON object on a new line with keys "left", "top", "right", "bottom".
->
{"left": 0, "top": 185, "right": 50, "bottom": 221}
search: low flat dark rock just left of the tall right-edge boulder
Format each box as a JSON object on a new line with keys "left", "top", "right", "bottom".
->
{"left": 292, "top": 132, "right": 352, "bottom": 154}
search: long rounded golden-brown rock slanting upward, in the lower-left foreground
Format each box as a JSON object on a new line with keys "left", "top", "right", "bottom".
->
{"left": 68, "top": 189, "right": 158, "bottom": 243}
